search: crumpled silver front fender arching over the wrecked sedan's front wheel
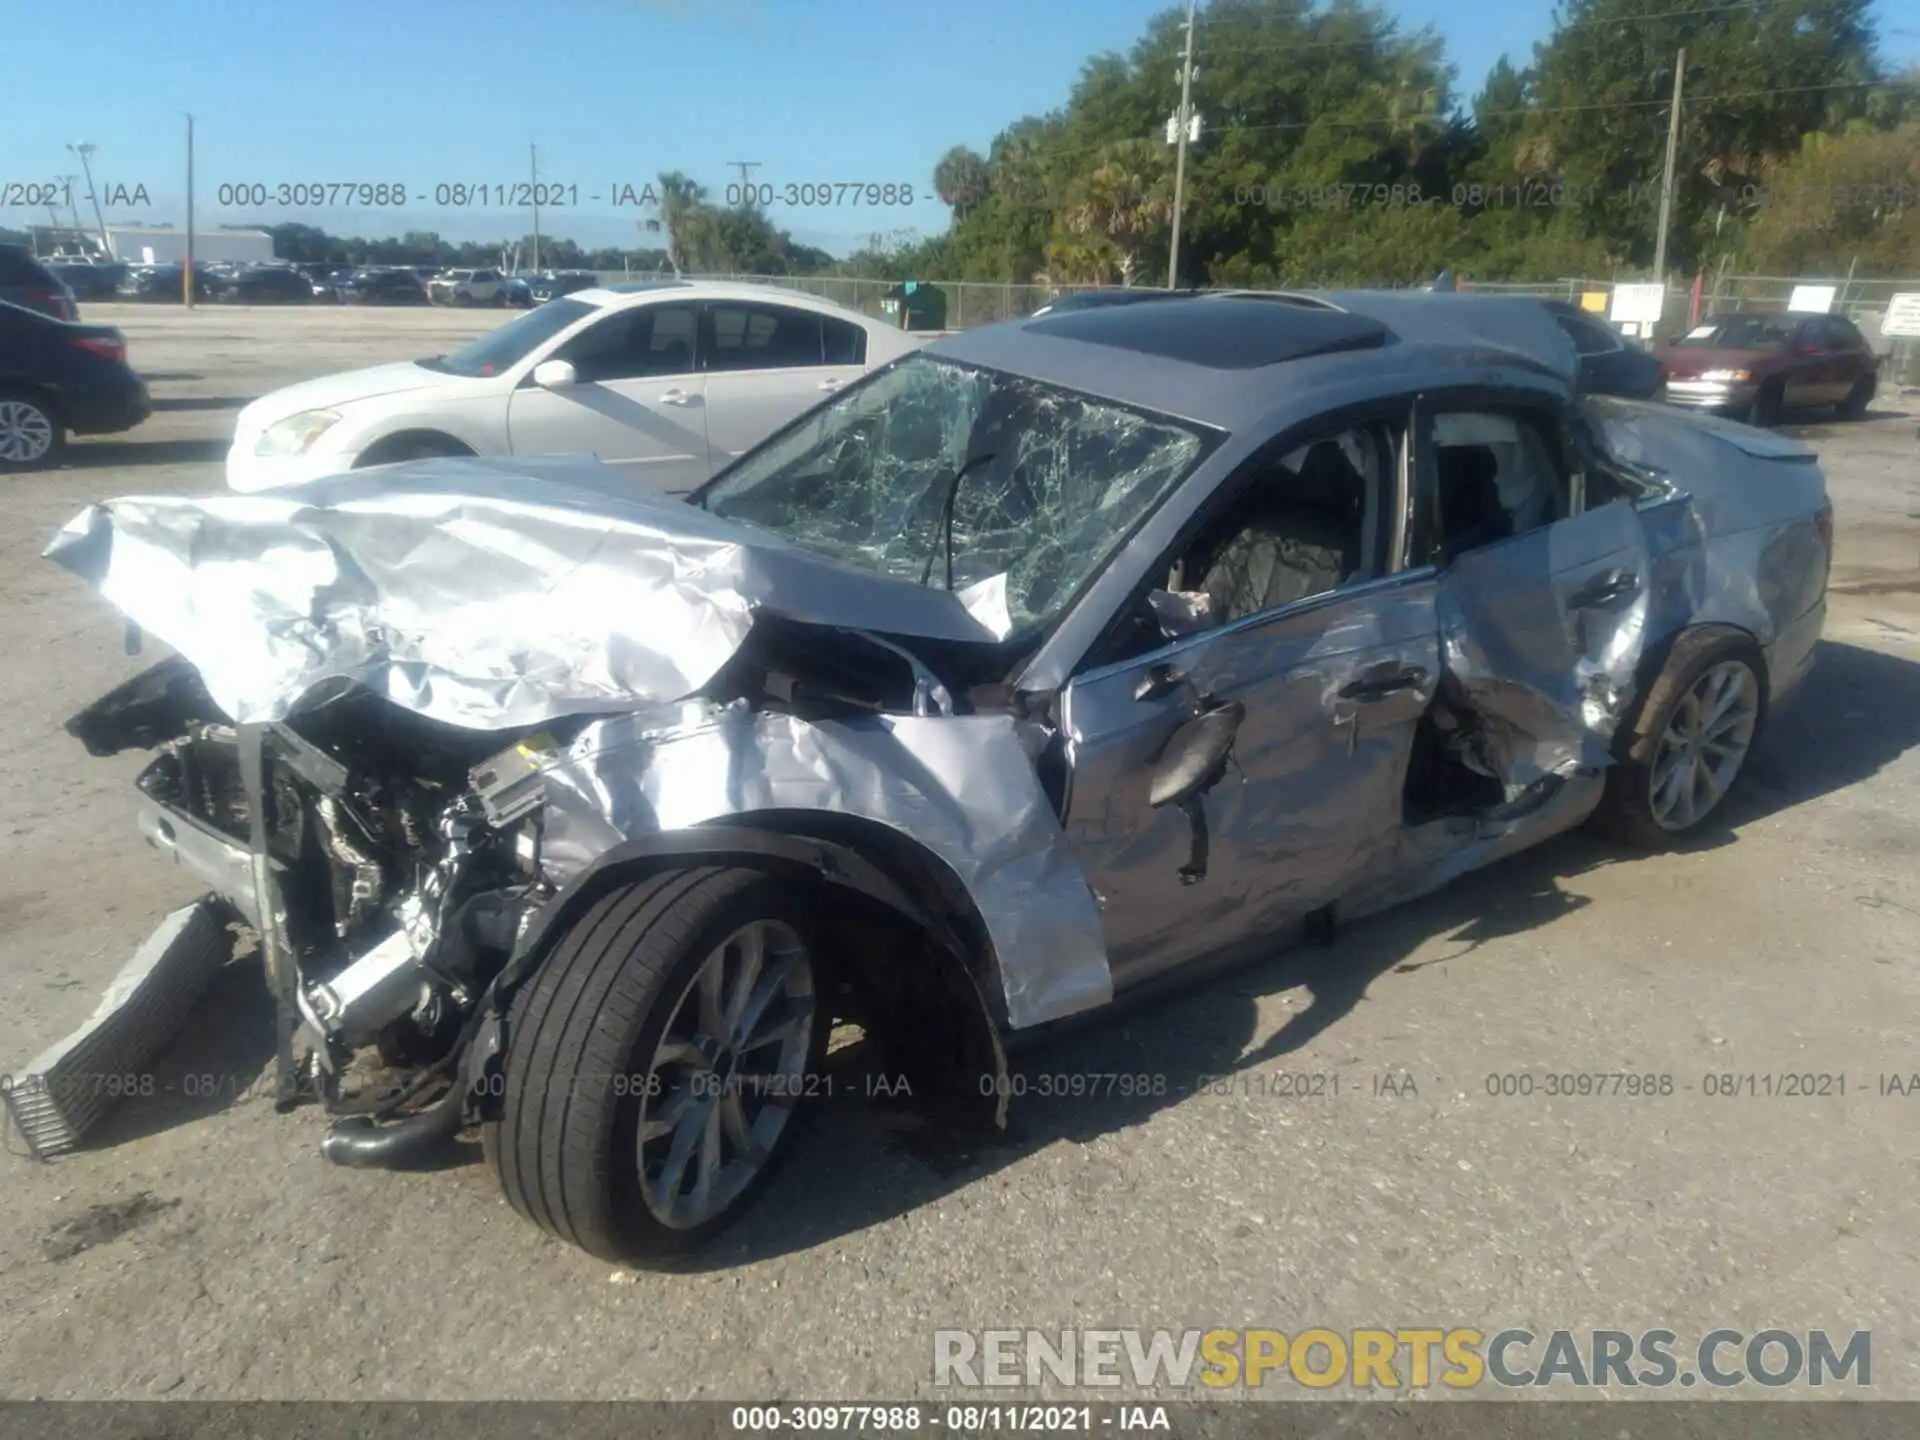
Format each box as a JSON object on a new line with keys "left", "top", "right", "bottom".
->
{"left": 522, "top": 703, "right": 1114, "bottom": 1029}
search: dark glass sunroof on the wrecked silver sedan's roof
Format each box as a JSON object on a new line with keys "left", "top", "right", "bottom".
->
{"left": 1027, "top": 298, "right": 1394, "bottom": 371}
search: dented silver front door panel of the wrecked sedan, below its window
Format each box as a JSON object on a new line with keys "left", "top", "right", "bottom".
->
{"left": 1062, "top": 570, "right": 1440, "bottom": 989}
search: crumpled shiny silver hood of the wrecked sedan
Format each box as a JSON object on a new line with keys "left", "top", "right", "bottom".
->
{"left": 46, "top": 457, "right": 998, "bottom": 730}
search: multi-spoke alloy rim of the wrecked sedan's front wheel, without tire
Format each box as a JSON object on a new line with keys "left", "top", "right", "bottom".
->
{"left": 639, "top": 920, "right": 814, "bottom": 1229}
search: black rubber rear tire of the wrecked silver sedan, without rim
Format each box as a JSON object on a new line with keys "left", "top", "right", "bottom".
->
{"left": 1590, "top": 628, "right": 1766, "bottom": 851}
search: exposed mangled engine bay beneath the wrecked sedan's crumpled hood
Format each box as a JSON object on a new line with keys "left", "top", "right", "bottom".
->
{"left": 69, "top": 659, "right": 559, "bottom": 1128}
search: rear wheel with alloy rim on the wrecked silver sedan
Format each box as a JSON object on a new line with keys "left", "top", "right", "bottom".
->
{"left": 1594, "top": 630, "right": 1766, "bottom": 849}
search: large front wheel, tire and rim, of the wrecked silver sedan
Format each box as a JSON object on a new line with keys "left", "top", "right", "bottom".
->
{"left": 484, "top": 866, "right": 828, "bottom": 1260}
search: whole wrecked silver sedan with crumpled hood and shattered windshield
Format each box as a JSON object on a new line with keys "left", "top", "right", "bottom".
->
{"left": 30, "top": 294, "right": 1832, "bottom": 1258}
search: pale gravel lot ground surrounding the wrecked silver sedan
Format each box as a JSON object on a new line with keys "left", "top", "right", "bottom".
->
{"left": 0, "top": 305, "right": 1920, "bottom": 1400}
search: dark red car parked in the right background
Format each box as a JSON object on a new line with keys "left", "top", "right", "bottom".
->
{"left": 1655, "top": 313, "right": 1880, "bottom": 424}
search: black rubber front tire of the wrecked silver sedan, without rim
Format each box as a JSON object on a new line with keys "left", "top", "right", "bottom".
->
{"left": 482, "top": 866, "right": 829, "bottom": 1261}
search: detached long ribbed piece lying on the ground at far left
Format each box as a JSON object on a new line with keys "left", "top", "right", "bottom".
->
{"left": 6, "top": 895, "right": 234, "bottom": 1160}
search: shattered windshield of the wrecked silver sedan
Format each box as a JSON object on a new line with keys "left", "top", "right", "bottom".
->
{"left": 699, "top": 355, "right": 1215, "bottom": 632}
